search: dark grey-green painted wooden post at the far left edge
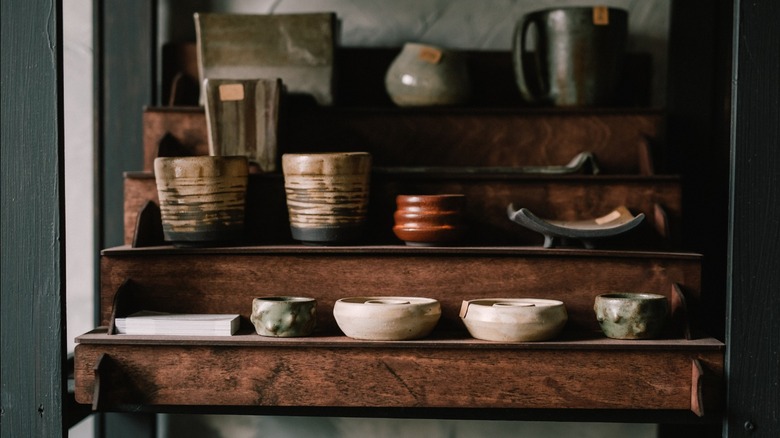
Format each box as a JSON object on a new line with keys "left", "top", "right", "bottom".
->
{"left": 0, "top": 0, "right": 67, "bottom": 437}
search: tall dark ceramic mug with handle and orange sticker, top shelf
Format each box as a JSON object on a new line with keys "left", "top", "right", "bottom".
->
{"left": 512, "top": 6, "right": 628, "bottom": 107}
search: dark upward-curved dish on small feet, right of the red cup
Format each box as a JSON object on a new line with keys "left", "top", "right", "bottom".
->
{"left": 507, "top": 204, "right": 645, "bottom": 249}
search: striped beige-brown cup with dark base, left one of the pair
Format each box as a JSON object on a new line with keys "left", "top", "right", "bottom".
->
{"left": 154, "top": 156, "right": 249, "bottom": 246}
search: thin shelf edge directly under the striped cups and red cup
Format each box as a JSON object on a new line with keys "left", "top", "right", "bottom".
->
{"left": 100, "top": 244, "right": 703, "bottom": 261}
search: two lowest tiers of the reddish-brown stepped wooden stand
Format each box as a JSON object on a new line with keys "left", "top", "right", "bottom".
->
{"left": 75, "top": 245, "right": 724, "bottom": 422}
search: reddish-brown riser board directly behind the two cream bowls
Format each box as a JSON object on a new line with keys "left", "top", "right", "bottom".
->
{"left": 101, "top": 246, "right": 701, "bottom": 333}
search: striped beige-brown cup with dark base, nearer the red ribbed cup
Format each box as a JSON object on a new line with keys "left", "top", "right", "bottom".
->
{"left": 282, "top": 152, "right": 371, "bottom": 245}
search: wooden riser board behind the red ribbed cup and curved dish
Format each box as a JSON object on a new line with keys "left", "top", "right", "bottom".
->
{"left": 124, "top": 173, "right": 682, "bottom": 249}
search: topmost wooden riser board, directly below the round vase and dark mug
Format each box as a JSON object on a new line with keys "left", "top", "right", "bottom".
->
{"left": 142, "top": 106, "right": 665, "bottom": 174}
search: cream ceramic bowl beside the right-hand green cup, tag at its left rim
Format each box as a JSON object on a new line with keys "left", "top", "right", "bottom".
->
{"left": 460, "top": 298, "right": 569, "bottom": 342}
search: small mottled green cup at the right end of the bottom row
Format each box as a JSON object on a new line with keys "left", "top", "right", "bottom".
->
{"left": 593, "top": 293, "right": 669, "bottom": 339}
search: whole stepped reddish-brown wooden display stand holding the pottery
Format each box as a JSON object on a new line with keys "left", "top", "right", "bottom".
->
{"left": 75, "top": 41, "right": 724, "bottom": 422}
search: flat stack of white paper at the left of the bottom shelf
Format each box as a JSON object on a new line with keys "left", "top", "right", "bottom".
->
{"left": 114, "top": 311, "right": 241, "bottom": 336}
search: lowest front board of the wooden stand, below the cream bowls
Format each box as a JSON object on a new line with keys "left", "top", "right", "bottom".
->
{"left": 75, "top": 328, "right": 723, "bottom": 415}
